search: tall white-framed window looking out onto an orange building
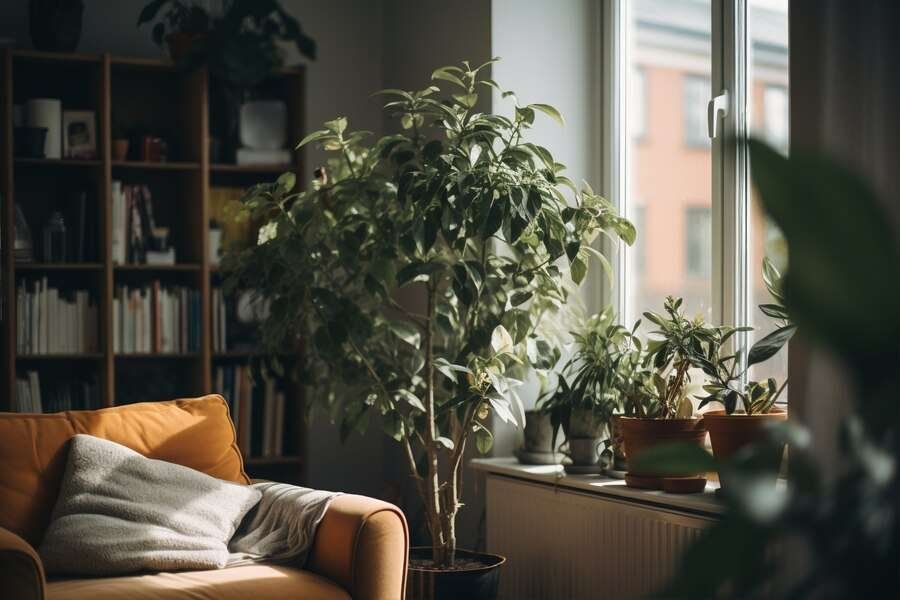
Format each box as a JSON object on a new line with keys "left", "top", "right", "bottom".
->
{"left": 603, "top": 0, "right": 790, "bottom": 392}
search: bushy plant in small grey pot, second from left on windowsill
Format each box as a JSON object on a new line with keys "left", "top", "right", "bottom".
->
{"left": 544, "top": 307, "right": 632, "bottom": 474}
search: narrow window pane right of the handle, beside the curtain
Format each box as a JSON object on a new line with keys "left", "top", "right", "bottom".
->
{"left": 747, "top": 0, "right": 790, "bottom": 390}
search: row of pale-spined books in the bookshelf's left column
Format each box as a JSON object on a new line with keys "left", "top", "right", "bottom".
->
{"left": 16, "top": 277, "right": 99, "bottom": 354}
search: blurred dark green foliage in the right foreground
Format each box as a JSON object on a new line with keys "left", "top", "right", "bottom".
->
{"left": 662, "top": 141, "right": 900, "bottom": 598}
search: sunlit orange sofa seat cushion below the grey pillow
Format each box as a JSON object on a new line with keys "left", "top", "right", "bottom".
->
{"left": 45, "top": 565, "right": 350, "bottom": 600}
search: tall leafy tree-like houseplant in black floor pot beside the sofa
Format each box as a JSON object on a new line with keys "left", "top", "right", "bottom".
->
{"left": 224, "top": 62, "right": 634, "bottom": 598}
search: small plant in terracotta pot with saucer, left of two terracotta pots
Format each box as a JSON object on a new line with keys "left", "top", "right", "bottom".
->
{"left": 619, "top": 296, "right": 714, "bottom": 493}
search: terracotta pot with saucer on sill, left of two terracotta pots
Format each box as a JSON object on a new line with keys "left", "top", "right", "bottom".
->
{"left": 619, "top": 417, "right": 706, "bottom": 492}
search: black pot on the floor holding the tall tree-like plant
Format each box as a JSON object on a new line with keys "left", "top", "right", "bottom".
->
{"left": 406, "top": 547, "right": 506, "bottom": 600}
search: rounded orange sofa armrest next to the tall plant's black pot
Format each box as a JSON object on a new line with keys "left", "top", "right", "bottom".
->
{"left": 307, "top": 494, "right": 409, "bottom": 600}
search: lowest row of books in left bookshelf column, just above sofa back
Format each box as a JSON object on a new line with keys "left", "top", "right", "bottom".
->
{"left": 16, "top": 371, "right": 100, "bottom": 413}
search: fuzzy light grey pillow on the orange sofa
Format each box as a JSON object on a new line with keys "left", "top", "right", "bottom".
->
{"left": 39, "top": 435, "right": 261, "bottom": 575}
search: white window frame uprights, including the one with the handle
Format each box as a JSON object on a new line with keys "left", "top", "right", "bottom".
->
{"left": 598, "top": 0, "right": 750, "bottom": 366}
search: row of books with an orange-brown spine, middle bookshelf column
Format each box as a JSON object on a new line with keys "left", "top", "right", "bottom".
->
{"left": 113, "top": 280, "right": 202, "bottom": 354}
